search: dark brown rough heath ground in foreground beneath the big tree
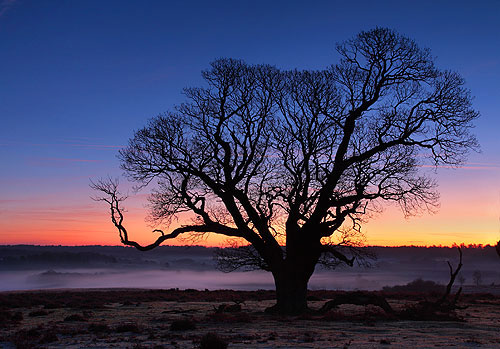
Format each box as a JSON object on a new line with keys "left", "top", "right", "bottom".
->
{"left": 0, "top": 289, "right": 500, "bottom": 348}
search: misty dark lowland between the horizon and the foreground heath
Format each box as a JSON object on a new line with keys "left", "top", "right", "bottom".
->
{"left": 0, "top": 246, "right": 500, "bottom": 292}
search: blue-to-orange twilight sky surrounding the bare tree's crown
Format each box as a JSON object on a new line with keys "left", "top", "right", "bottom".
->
{"left": 0, "top": 0, "right": 500, "bottom": 246}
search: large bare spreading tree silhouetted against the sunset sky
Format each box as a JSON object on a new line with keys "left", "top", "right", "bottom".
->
{"left": 93, "top": 28, "right": 479, "bottom": 314}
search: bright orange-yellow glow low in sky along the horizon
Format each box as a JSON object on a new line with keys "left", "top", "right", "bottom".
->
{"left": 0, "top": 200, "right": 500, "bottom": 247}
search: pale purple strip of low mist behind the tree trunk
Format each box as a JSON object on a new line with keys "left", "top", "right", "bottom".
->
{"left": 0, "top": 269, "right": 442, "bottom": 291}
